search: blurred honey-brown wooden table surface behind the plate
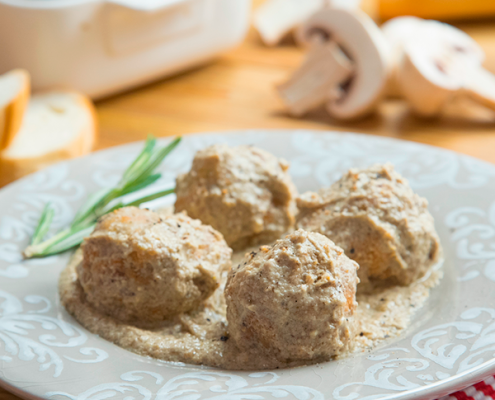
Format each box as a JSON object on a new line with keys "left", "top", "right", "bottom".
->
{"left": 0, "top": 5, "right": 495, "bottom": 400}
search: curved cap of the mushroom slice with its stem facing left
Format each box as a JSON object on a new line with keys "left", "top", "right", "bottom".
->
{"left": 296, "top": 9, "right": 390, "bottom": 119}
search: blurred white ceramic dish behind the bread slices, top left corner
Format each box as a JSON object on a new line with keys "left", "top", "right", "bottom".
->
{"left": 0, "top": 0, "right": 251, "bottom": 98}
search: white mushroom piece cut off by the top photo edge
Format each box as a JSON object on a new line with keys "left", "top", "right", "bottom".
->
{"left": 253, "top": 0, "right": 327, "bottom": 46}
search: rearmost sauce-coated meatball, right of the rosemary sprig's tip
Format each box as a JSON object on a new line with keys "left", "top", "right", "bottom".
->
{"left": 175, "top": 145, "right": 297, "bottom": 249}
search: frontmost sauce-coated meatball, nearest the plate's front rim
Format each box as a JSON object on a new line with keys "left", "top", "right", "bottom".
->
{"left": 225, "top": 230, "right": 359, "bottom": 363}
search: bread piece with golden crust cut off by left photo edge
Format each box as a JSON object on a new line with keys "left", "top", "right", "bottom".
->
{"left": 0, "top": 69, "right": 31, "bottom": 150}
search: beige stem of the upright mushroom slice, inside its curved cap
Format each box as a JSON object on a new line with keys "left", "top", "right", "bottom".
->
{"left": 278, "top": 40, "right": 354, "bottom": 116}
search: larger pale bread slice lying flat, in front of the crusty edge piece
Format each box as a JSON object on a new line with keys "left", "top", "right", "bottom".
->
{"left": 0, "top": 91, "right": 96, "bottom": 186}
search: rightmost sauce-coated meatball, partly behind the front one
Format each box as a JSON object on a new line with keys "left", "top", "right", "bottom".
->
{"left": 297, "top": 164, "right": 441, "bottom": 285}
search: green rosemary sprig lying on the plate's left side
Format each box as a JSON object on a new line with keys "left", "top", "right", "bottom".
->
{"left": 24, "top": 136, "right": 181, "bottom": 258}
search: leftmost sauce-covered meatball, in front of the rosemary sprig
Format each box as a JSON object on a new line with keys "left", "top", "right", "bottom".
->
{"left": 77, "top": 207, "right": 232, "bottom": 327}
